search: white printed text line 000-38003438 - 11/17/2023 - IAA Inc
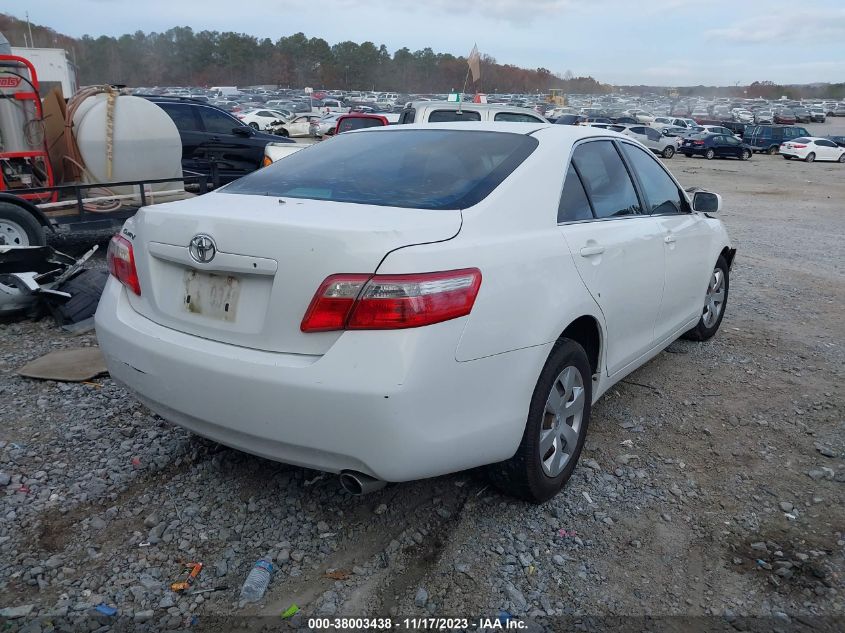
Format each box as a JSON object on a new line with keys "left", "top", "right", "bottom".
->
{"left": 308, "top": 612, "right": 528, "bottom": 631}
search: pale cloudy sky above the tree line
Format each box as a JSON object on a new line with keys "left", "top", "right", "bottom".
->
{"left": 6, "top": 0, "right": 845, "bottom": 86}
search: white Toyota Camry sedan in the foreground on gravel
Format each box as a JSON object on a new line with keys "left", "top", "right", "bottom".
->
{"left": 96, "top": 123, "right": 735, "bottom": 502}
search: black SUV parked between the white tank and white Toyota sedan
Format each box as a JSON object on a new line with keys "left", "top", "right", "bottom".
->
{"left": 138, "top": 95, "right": 294, "bottom": 186}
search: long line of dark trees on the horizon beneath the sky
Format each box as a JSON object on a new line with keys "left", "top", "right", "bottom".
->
{"left": 0, "top": 14, "right": 612, "bottom": 93}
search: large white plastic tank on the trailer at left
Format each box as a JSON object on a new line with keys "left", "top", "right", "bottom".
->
{"left": 73, "top": 94, "right": 184, "bottom": 194}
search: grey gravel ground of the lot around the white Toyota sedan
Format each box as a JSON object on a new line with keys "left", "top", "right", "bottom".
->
{"left": 0, "top": 121, "right": 845, "bottom": 632}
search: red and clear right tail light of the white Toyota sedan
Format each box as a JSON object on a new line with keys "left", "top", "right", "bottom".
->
{"left": 300, "top": 268, "right": 481, "bottom": 332}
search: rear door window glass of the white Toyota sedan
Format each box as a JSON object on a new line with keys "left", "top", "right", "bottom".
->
{"left": 572, "top": 141, "right": 641, "bottom": 218}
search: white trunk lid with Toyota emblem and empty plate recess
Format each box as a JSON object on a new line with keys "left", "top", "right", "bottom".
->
{"left": 123, "top": 193, "right": 461, "bottom": 355}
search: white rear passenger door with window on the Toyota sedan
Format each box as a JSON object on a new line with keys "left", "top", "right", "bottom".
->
{"left": 559, "top": 140, "right": 664, "bottom": 374}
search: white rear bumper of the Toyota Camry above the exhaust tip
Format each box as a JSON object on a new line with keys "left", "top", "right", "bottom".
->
{"left": 96, "top": 279, "right": 551, "bottom": 481}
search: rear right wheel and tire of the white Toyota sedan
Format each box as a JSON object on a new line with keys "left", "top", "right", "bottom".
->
{"left": 486, "top": 338, "right": 593, "bottom": 503}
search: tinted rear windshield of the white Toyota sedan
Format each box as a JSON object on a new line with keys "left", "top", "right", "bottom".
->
{"left": 221, "top": 129, "right": 538, "bottom": 209}
